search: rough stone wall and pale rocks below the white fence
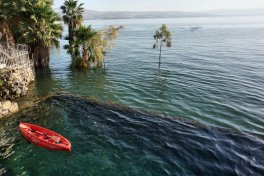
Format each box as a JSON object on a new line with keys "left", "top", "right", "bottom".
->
{"left": 0, "top": 67, "right": 35, "bottom": 118}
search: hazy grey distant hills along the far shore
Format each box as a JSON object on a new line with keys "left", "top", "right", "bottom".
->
{"left": 55, "top": 9, "right": 264, "bottom": 20}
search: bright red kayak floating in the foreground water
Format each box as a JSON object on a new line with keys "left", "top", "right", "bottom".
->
{"left": 19, "top": 122, "right": 71, "bottom": 152}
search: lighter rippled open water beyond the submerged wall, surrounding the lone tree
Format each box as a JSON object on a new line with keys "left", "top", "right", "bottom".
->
{"left": 49, "top": 17, "right": 264, "bottom": 134}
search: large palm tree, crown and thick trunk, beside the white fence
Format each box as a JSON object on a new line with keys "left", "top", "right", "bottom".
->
{"left": 19, "top": 1, "right": 63, "bottom": 67}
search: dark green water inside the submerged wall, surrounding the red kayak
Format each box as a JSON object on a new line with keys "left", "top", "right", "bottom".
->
{"left": 0, "top": 94, "right": 264, "bottom": 176}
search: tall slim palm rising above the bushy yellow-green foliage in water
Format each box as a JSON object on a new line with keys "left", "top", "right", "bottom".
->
{"left": 61, "top": 0, "right": 84, "bottom": 45}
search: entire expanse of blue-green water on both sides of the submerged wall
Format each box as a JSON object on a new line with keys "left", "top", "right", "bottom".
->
{"left": 0, "top": 17, "right": 264, "bottom": 175}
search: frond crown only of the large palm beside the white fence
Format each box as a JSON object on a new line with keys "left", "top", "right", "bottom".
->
{"left": 18, "top": 1, "right": 63, "bottom": 47}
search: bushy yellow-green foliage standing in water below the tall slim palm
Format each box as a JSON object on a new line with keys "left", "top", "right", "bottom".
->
{"left": 69, "top": 26, "right": 119, "bottom": 67}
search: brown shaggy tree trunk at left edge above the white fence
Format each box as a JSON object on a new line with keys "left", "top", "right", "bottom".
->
{"left": 0, "top": 20, "right": 15, "bottom": 46}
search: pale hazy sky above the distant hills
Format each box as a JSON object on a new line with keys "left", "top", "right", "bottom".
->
{"left": 54, "top": 0, "right": 264, "bottom": 11}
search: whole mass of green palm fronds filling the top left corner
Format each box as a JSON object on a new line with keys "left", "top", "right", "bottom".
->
{"left": 0, "top": 0, "right": 63, "bottom": 47}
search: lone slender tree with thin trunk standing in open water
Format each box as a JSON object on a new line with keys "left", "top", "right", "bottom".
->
{"left": 153, "top": 24, "right": 172, "bottom": 67}
